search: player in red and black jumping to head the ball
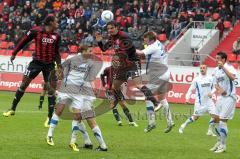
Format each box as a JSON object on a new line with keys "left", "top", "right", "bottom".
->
{"left": 96, "top": 21, "right": 161, "bottom": 118}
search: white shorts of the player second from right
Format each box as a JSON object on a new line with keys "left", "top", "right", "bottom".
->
{"left": 193, "top": 99, "right": 217, "bottom": 116}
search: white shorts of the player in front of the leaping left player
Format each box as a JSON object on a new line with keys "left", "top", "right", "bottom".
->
{"left": 57, "top": 92, "right": 96, "bottom": 112}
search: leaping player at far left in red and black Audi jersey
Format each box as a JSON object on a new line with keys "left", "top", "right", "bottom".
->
{"left": 3, "top": 15, "right": 62, "bottom": 124}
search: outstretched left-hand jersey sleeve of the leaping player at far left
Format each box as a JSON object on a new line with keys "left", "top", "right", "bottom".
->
{"left": 12, "top": 29, "right": 37, "bottom": 55}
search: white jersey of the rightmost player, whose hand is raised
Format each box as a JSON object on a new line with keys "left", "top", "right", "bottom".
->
{"left": 213, "top": 63, "right": 237, "bottom": 99}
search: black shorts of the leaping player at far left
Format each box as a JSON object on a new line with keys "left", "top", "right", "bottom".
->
{"left": 24, "top": 60, "right": 55, "bottom": 82}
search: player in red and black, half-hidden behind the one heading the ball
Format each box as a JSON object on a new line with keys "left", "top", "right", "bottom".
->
{"left": 101, "top": 66, "right": 138, "bottom": 127}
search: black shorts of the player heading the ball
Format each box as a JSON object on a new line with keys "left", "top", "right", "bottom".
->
{"left": 113, "top": 61, "right": 141, "bottom": 82}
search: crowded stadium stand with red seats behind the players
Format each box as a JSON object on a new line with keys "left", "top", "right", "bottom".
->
{"left": 0, "top": 0, "right": 240, "bottom": 63}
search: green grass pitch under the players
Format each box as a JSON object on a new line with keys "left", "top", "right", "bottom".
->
{"left": 0, "top": 92, "right": 240, "bottom": 159}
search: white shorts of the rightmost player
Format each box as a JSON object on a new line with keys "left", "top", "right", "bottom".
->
{"left": 216, "top": 96, "right": 236, "bottom": 119}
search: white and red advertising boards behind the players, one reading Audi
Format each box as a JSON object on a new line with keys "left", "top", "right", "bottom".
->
{"left": 0, "top": 56, "right": 240, "bottom": 107}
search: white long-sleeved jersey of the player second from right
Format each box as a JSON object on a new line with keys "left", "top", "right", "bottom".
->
{"left": 186, "top": 75, "right": 213, "bottom": 105}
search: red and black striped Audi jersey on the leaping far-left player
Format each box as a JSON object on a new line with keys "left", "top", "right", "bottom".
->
{"left": 13, "top": 27, "right": 61, "bottom": 64}
